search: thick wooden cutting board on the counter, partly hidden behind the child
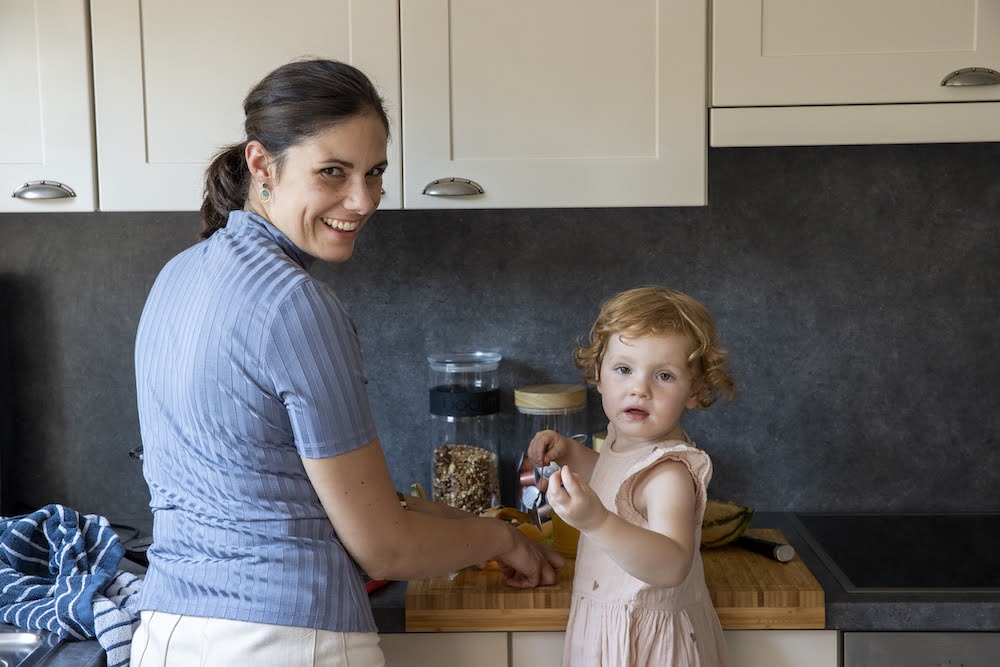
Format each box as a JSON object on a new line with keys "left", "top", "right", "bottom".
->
{"left": 406, "top": 529, "right": 826, "bottom": 632}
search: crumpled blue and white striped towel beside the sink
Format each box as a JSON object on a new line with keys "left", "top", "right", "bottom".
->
{"left": 0, "top": 505, "right": 142, "bottom": 667}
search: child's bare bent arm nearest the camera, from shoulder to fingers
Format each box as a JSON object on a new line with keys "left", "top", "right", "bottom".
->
{"left": 546, "top": 461, "right": 698, "bottom": 587}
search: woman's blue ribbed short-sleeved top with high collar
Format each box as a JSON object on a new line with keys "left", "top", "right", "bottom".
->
{"left": 135, "top": 211, "right": 376, "bottom": 632}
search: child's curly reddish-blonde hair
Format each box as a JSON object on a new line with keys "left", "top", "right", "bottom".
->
{"left": 573, "top": 286, "right": 736, "bottom": 409}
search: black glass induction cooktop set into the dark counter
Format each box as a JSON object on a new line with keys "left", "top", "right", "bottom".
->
{"left": 795, "top": 513, "right": 1000, "bottom": 593}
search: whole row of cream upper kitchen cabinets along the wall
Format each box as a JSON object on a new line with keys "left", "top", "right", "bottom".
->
{"left": 17, "top": 0, "right": 1000, "bottom": 212}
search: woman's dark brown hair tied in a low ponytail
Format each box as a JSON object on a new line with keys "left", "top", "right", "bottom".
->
{"left": 201, "top": 59, "right": 389, "bottom": 239}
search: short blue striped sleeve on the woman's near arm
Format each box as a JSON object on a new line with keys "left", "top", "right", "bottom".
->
{"left": 266, "top": 281, "right": 376, "bottom": 458}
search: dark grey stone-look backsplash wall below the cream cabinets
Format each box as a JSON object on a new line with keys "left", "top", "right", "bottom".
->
{"left": 0, "top": 144, "right": 1000, "bottom": 520}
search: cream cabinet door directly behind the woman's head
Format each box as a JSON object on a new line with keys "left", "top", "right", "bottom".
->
{"left": 90, "top": 0, "right": 402, "bottom": 211}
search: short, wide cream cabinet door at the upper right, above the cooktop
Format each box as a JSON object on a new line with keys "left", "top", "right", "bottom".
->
{"left": 712, "top": 0, "right": 1000, "bottom": 107}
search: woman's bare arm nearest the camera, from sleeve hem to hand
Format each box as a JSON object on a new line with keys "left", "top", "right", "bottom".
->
{"left": 302, "top": 439, "right": 565, "bottom": 587}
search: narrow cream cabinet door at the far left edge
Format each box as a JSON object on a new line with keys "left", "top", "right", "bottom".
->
{"left": 0, "top": 0, "right": 95, "bottom": 212}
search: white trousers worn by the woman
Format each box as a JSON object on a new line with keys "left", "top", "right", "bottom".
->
{"left": 130, "top": 611, "right": 385, "bottom": 667}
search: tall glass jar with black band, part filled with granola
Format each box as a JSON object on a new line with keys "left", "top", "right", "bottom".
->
{"left": 427, "top": 352, "right": 501, "bottom": 514}
